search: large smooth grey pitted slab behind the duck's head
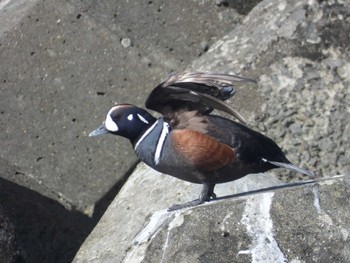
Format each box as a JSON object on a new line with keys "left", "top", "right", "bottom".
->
{"left": 0, "top": 0, "right": 260, "bottom": 217}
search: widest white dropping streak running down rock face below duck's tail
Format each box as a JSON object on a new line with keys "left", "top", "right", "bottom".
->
{"left": 238, "top": 193, "right": 287, "bottom": 263}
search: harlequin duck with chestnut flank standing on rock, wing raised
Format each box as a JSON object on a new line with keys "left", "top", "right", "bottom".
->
{"left": 89, "top": 73, "right": 313, "bottom": 210}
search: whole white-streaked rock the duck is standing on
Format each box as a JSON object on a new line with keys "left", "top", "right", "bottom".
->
{"left": 73, "top": 164, "right": 350, "bottom": 263}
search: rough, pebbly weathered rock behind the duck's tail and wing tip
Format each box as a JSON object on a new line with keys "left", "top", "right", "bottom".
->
{"left": 191, "top": 0, "right": 350, "bottom": 180}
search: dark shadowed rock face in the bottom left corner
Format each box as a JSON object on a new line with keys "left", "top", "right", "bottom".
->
{"left": 0, "top": 172, "right": 96, "bottom": 263}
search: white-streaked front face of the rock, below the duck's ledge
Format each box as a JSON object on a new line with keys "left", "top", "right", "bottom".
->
{"left": 139, "top": 177, "right": 350, "bottom": 263}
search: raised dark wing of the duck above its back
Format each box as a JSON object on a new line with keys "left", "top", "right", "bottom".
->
{"left": 146, "top": 72, "right": 256, "bottom": 126}
